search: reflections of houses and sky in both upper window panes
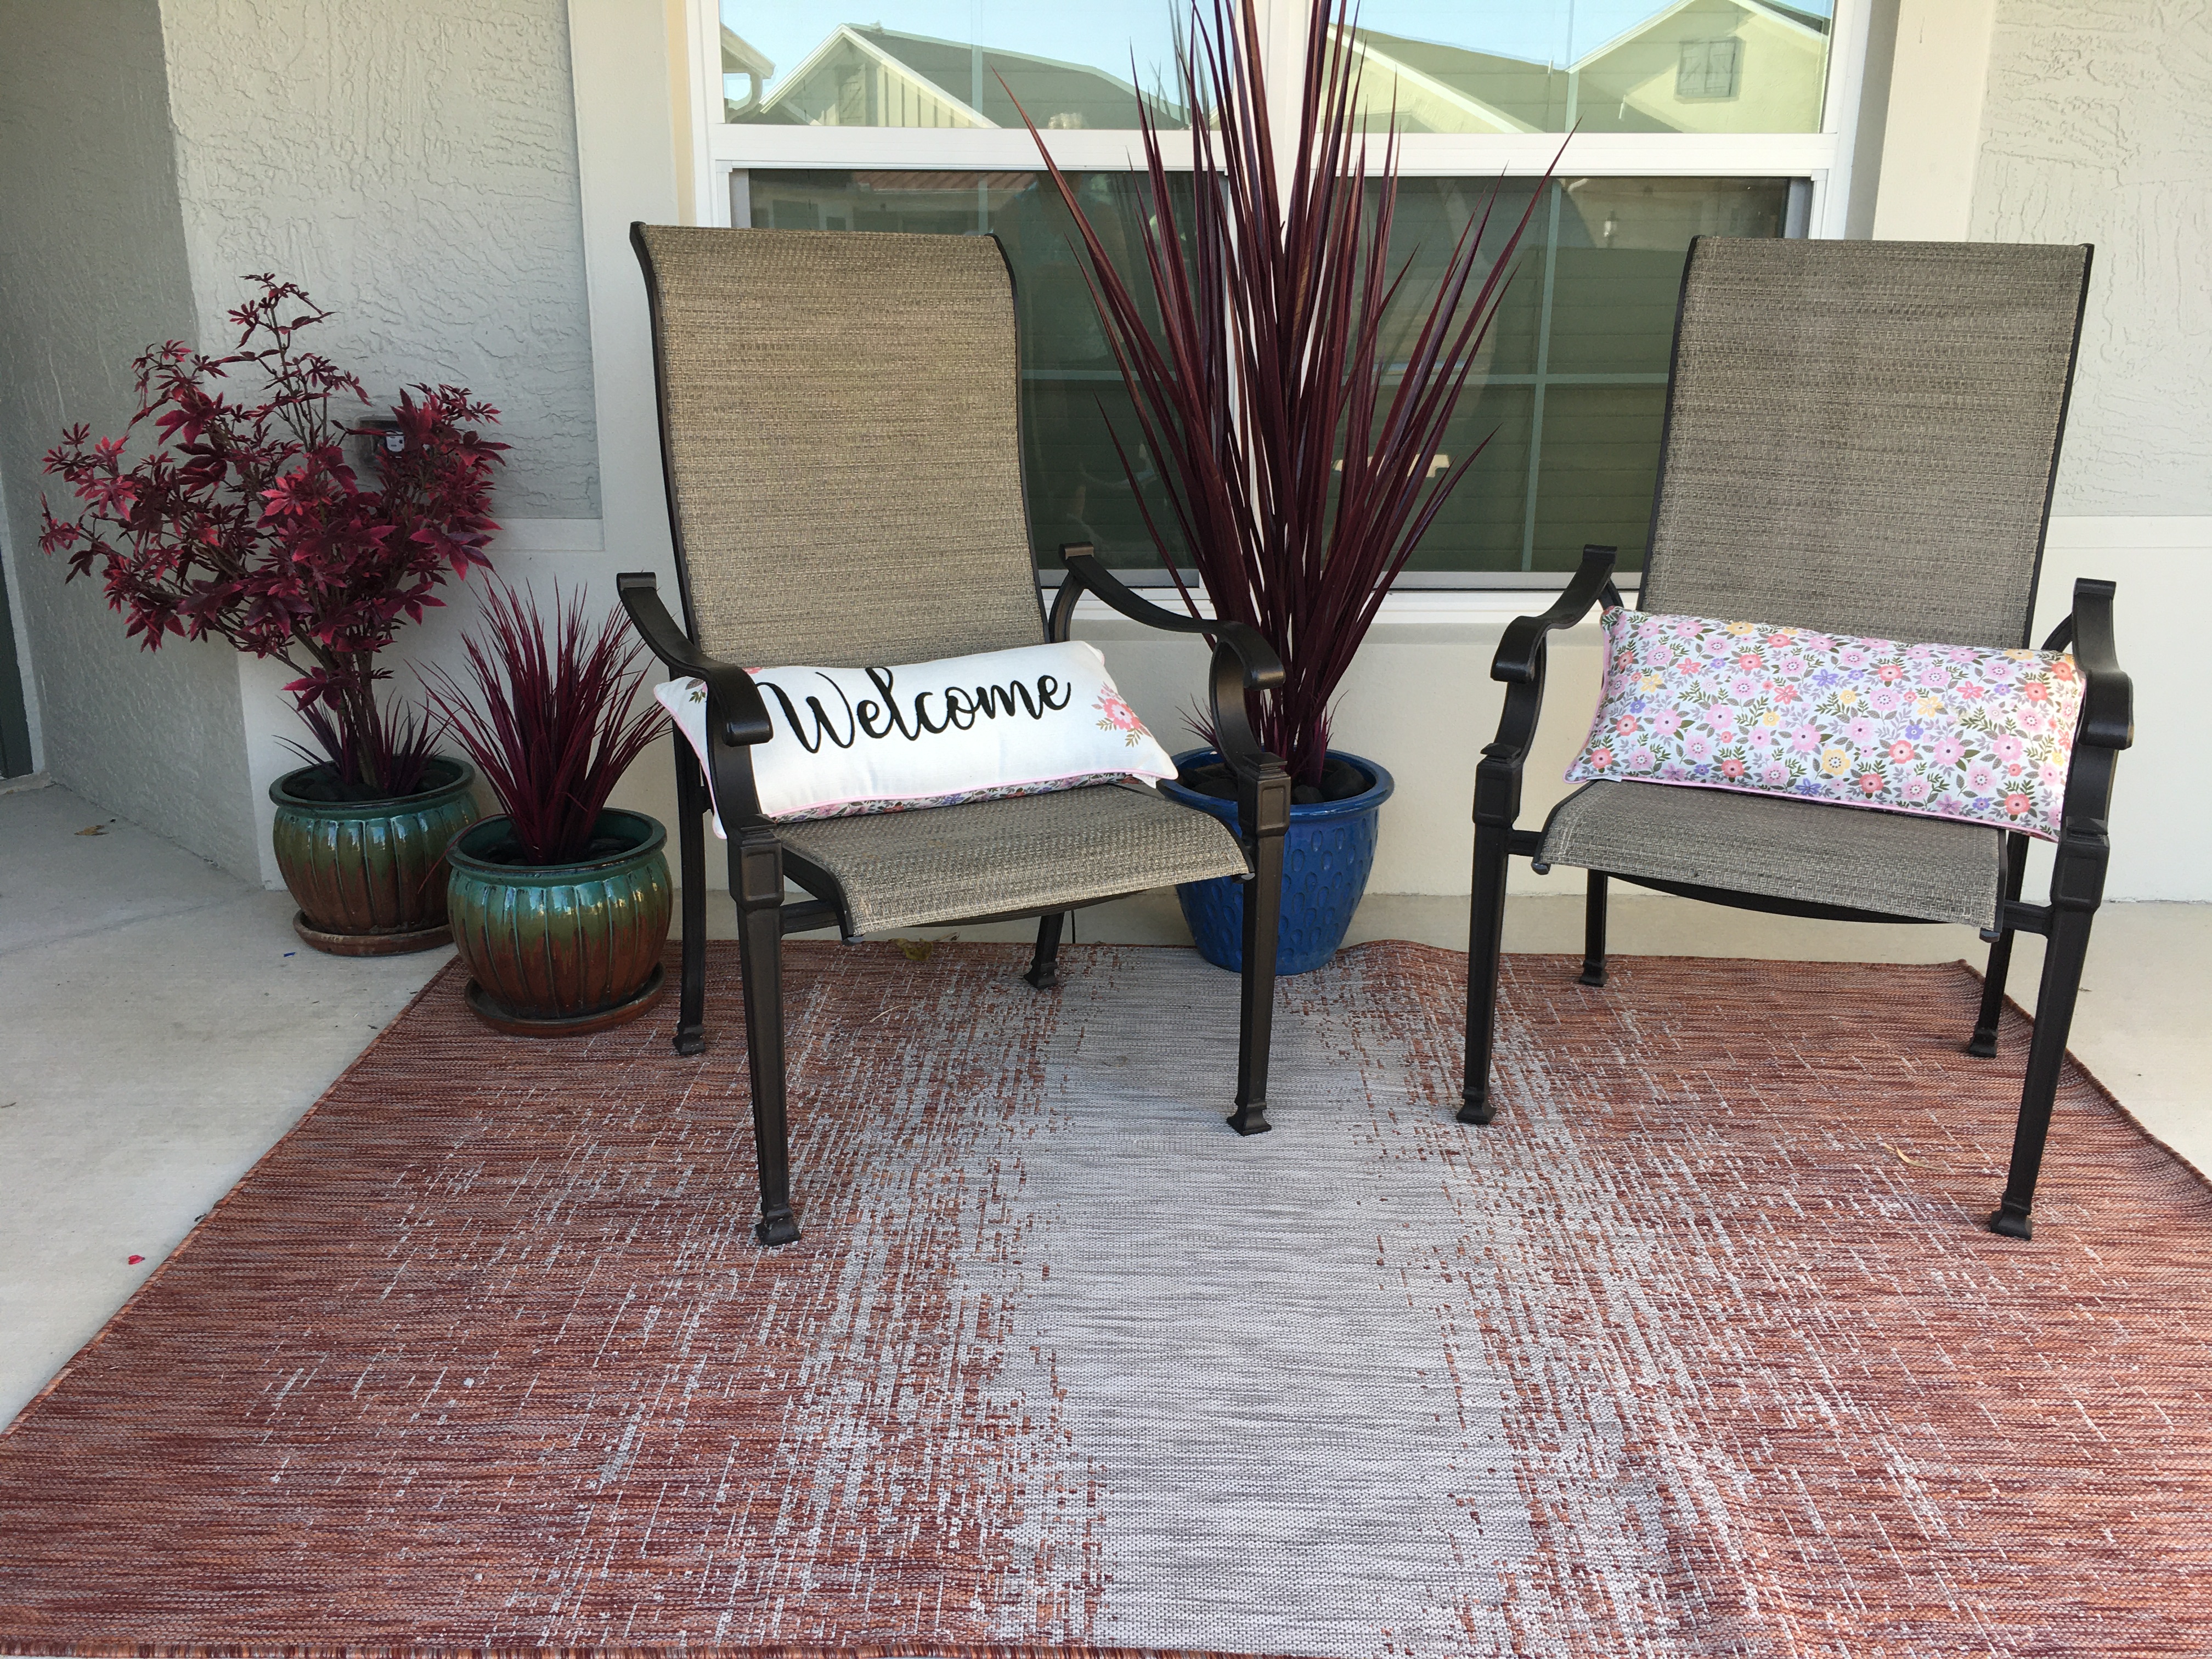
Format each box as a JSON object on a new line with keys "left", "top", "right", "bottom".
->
{"left": 721, "top": 0, "right": 1834, "bottom": 133}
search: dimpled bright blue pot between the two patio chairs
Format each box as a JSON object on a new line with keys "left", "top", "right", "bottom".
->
{"left": 1159, "top": 750, "right": 1398, "bottom": 975}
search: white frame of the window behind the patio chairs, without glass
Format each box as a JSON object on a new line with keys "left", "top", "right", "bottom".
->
{"left": 686, "top": 0, "right": 1876, "bottom": 592}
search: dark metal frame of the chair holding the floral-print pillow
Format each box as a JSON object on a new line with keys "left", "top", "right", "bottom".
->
{"left": 1458, "top": 236, "right": 2135, "bottom": 1239}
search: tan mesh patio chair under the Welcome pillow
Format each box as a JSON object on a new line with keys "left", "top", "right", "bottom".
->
{"left": 619, "top": 225, "right": 1290, "bottom": 1245}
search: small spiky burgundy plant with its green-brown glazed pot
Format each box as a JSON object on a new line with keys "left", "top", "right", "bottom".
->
{"left": 422, "top": 586, "right": 673, "bottom": 1037}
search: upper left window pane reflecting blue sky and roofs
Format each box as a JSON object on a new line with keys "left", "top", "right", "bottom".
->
{"left": 721, "top": 0, "right": 1186, "bottom": 131}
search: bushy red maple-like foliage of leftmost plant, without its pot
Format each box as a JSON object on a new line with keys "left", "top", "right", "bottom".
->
{"left": 40, "top": 274, "right": 506, "bottom": 797}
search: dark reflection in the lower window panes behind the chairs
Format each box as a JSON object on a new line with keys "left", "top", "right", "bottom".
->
{"left": 732, "top": 168, "right": 1790, "bottom": 573}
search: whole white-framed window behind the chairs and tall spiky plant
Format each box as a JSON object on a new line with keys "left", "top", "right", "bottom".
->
{"left": 697, "top": 0, "right": 1863, "bottom": 586}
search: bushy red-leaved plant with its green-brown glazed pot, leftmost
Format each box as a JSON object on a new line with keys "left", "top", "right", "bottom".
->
{"left": 40, "top": 274, "right": 506, "bottom": 956}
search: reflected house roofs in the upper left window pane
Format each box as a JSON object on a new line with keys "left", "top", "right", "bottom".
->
{"left": 723, "top": 22, "right": 1183, "bottom": 131}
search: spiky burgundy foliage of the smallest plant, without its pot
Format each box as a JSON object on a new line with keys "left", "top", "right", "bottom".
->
{"left": 422, "top": 584, "right": 666, "bottom": 865}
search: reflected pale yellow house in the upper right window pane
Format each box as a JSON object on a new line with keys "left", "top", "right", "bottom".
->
{"left": 1352, "top": 0, "right": 1827, "bottom": 133}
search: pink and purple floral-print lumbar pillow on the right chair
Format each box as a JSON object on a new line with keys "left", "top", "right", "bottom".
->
{"left": 1566, "top": 606, "right": 2081, "bottom": 840}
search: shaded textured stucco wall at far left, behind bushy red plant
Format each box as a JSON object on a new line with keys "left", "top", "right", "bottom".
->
{"left": 0, "top": 0, "right": 259, "bottom": 874}
